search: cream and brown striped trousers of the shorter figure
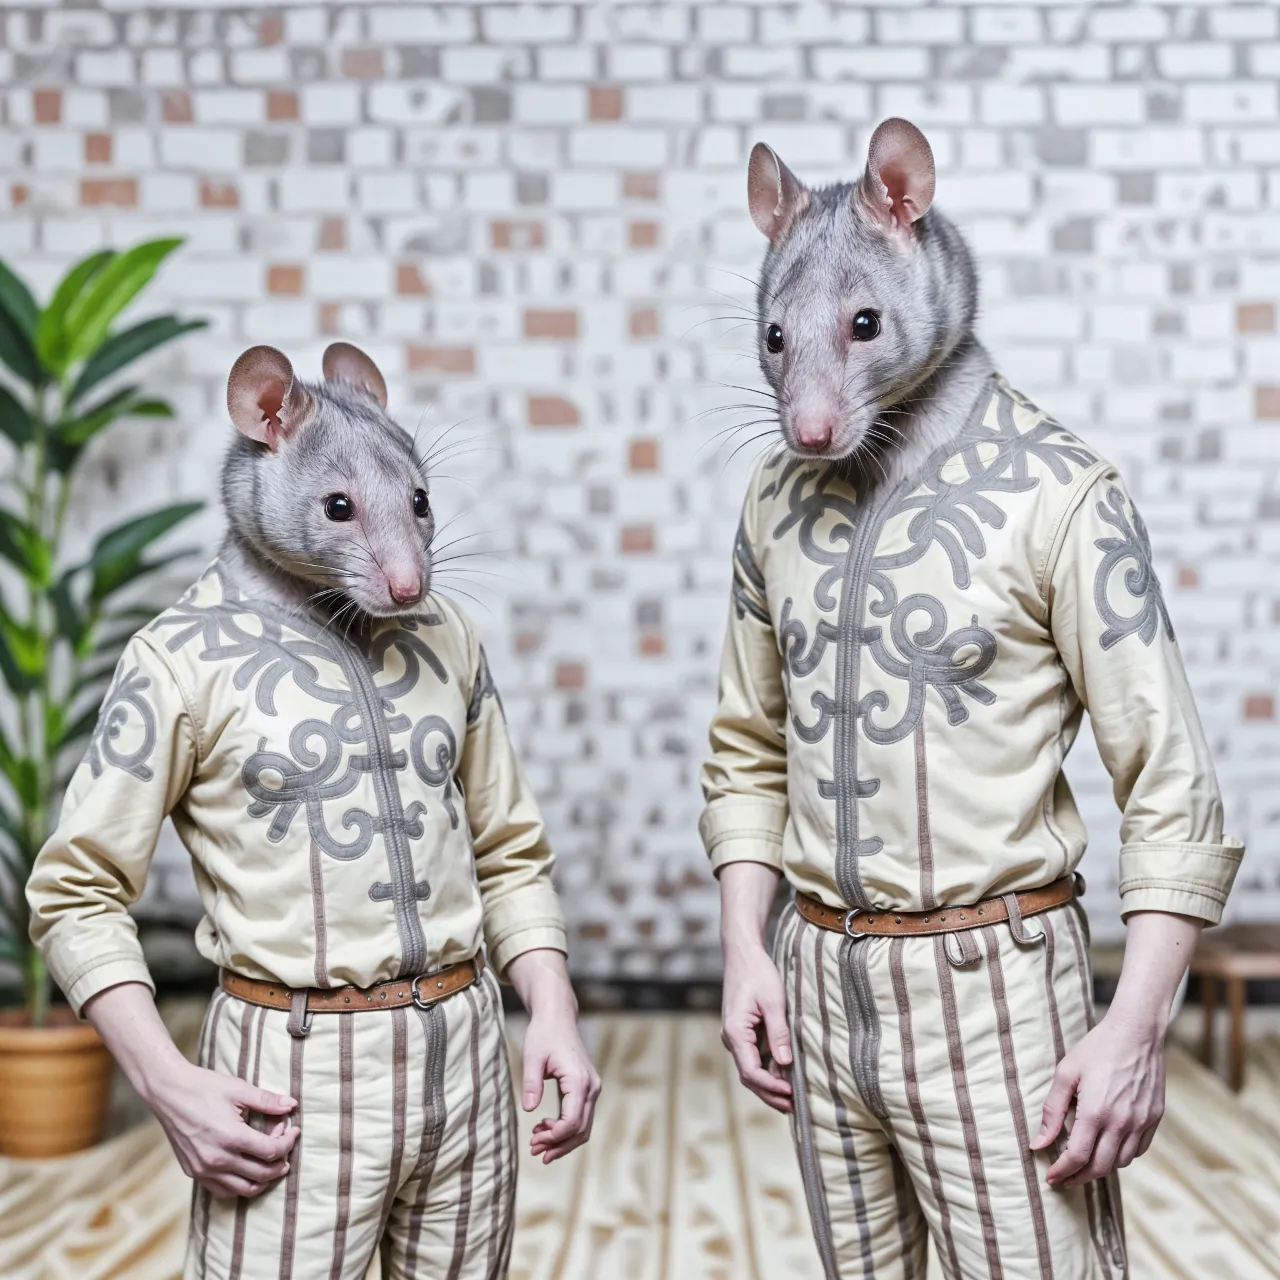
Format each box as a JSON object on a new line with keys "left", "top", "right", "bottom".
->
{"left": 183, "top": 968, "right": 516, "bottom": 1280}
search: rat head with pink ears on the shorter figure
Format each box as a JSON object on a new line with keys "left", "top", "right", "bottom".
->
{"left": 223, "top": 342, "right": 435, "bottom": 617}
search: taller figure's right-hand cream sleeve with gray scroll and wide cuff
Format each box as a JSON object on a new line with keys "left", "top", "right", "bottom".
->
{"left": 1047, "top": 468, "right": 1244, "bottom": 924}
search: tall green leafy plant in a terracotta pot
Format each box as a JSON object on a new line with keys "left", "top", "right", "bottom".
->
{"left": 0, "top": 239, "right": 204, "bottom": 1156}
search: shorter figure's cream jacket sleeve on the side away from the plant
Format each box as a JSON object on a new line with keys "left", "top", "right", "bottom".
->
{"left": 458, "top": 643, "right": 568, "bottom": 974}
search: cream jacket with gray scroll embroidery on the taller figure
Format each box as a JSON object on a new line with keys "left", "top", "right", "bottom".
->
{"left": 701, "top": 379, "right": 1243, "bottom": 923}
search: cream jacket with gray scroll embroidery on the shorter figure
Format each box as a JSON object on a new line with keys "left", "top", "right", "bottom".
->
{"left": 27, "top": 562, "right": 566, "bottom": 1009}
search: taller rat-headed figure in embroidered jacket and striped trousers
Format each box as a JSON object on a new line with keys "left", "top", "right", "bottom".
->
{"left": 701, "top": 120, "right": 1243, "bottom": 1280}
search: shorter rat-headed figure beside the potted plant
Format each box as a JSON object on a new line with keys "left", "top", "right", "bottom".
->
{"left": 28, "top": 343, "right": 599, "bottom": 1280}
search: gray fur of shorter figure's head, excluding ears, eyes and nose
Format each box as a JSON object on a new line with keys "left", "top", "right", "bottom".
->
{"left": 221, "top": 381, "right": 435, "bottom": 621}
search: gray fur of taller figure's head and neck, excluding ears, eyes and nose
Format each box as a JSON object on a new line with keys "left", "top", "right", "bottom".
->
{"left": 756, "top": 138, "right": 993, "bottom": 484}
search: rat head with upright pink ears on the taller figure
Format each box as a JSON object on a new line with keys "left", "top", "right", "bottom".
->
{"left": 748, "top": 119, "right": 977, "bottom": 460}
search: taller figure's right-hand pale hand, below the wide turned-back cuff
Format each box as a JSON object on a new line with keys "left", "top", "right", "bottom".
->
{"left": 1030, "top": 1007, "right": 1165, "bottom": 1187}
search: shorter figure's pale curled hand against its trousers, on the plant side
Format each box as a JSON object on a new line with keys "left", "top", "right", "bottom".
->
{"left": 145, "top": 1060, "right": 301, "bottom": 1198}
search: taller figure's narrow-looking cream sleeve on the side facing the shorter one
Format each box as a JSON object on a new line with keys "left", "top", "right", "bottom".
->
{"left": 699, "top": 481, "right": 787, "bottom": 872}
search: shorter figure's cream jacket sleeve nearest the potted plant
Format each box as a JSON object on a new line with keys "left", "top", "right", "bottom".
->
{"left": 27, "top": 636, "right": 197, "bottom": 1012}
